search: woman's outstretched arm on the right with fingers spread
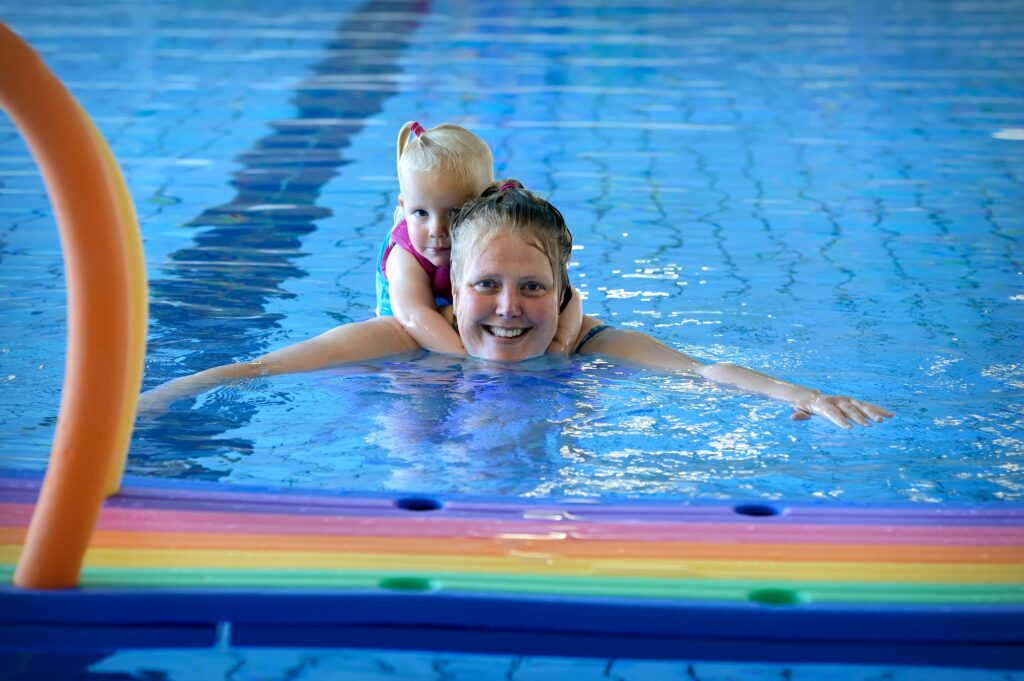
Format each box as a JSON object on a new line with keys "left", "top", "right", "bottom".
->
{"left": 580, "top": 317, "right": 892, "bottom": 428}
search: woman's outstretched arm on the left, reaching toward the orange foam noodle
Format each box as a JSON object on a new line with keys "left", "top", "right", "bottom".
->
{"left": 138, "top": 316, "right": 420, "bottom": 414}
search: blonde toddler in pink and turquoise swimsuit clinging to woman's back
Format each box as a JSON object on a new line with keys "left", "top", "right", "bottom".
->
{"left": 376, "top": 121, "right": 583, "bottom": 354}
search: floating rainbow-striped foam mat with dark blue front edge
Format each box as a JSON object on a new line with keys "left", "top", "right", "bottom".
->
{"left": 0, "top": 472, "right": 1024, "bottom": 669}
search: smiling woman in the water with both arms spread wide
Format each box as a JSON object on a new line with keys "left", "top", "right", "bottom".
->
{"left": 139, "top": 180, "right": 892, "bottom": 428}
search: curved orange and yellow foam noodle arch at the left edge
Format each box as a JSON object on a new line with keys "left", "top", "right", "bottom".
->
{"left": 0, "top": 23, "right": 146, "bottom": 589}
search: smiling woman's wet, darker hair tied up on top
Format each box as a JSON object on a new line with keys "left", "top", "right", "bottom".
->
{"left": 451, "top": 179, "right": 572, "bottom": 310}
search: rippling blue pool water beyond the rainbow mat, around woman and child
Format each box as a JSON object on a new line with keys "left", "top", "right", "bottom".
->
{"left": 0, "top": 3, "right": 1024, "bottom": 675}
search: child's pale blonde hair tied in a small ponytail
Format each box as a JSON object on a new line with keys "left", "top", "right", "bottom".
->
{"left": 397, "top": 121, "right": 495, "bottom": 195}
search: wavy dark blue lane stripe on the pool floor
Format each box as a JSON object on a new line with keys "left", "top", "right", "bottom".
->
{"left": 135, "top": 0, "right": 427, "bottom": 479}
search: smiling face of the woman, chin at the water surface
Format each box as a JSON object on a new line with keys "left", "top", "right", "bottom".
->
{"left": 453, "top": 233, "right": 558, "bottom": 361}
